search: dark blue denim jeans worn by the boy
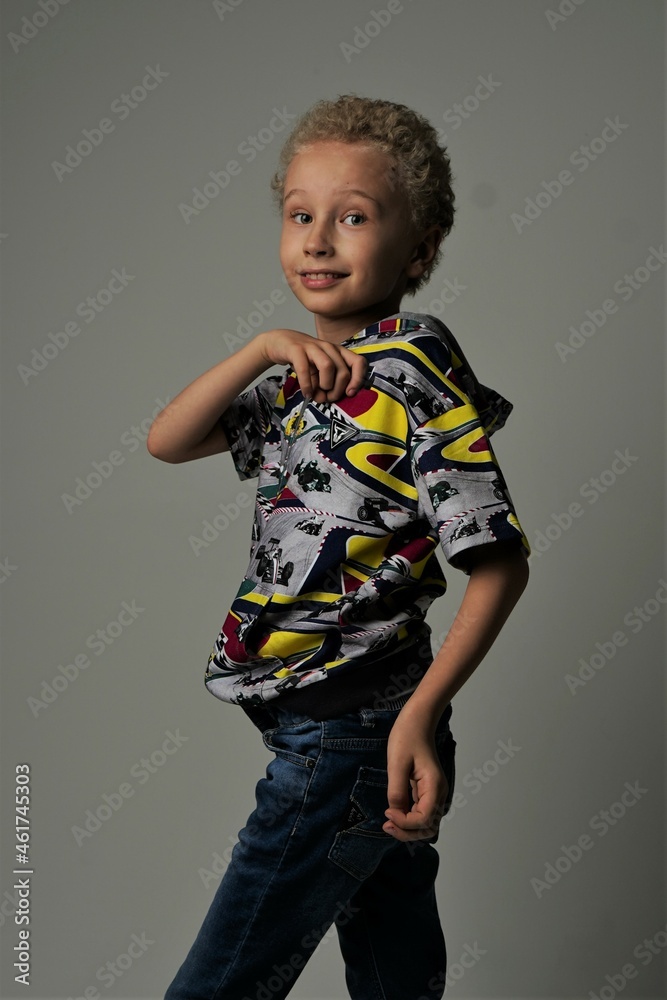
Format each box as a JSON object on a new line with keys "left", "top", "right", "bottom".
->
{"left": 164, "top": 695, "right": 456, "bottom": 1000}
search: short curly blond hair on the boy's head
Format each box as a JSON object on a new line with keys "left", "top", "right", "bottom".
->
{"left": 271, "top": 94, "right": 455, "bottom": 295}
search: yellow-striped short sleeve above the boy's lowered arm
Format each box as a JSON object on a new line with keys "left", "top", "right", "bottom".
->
{"left": 411, "top": 335, "right": 530, "bottom": 573}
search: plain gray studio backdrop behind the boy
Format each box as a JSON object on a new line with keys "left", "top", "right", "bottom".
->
{"left": 0, "top": 0, "right": 667, "bottom": 1000}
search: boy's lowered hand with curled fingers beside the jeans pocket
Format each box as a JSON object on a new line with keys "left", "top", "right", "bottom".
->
{"left": 382, "top": 712, "right": 449, "bottom": 841}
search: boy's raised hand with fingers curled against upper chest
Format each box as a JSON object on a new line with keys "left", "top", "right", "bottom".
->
{"left": 260, "top": 329, "right": 368, "bottom": 403}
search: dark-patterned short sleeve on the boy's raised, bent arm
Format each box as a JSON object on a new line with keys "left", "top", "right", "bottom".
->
{"left": 218, "top": 375, "right": 284, "bottom": 480}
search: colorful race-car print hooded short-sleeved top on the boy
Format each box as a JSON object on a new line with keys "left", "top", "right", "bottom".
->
{"left": 205, "top": 312, "right": 530, "bottom": 707}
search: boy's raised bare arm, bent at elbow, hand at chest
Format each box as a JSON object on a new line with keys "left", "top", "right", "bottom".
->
{"left": 146, "top": 330, "right": 366, "bottom": 464}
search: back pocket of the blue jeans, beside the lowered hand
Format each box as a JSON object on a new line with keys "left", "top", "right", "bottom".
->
{"left": 328, "top": 765, "right": 396, "bottom": 879}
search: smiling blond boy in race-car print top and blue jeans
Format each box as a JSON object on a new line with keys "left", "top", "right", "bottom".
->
{"left": 153, "top": 95, "right": 529, "bottom": 1000}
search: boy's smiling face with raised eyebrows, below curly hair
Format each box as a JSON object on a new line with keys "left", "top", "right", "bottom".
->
{"left": 280, "top": 141, "right": 425, "bottom": 343}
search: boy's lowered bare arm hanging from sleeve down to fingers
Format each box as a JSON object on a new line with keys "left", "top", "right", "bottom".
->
{"left": 383, "top": 542, "right": 529, "bottom": 841}
